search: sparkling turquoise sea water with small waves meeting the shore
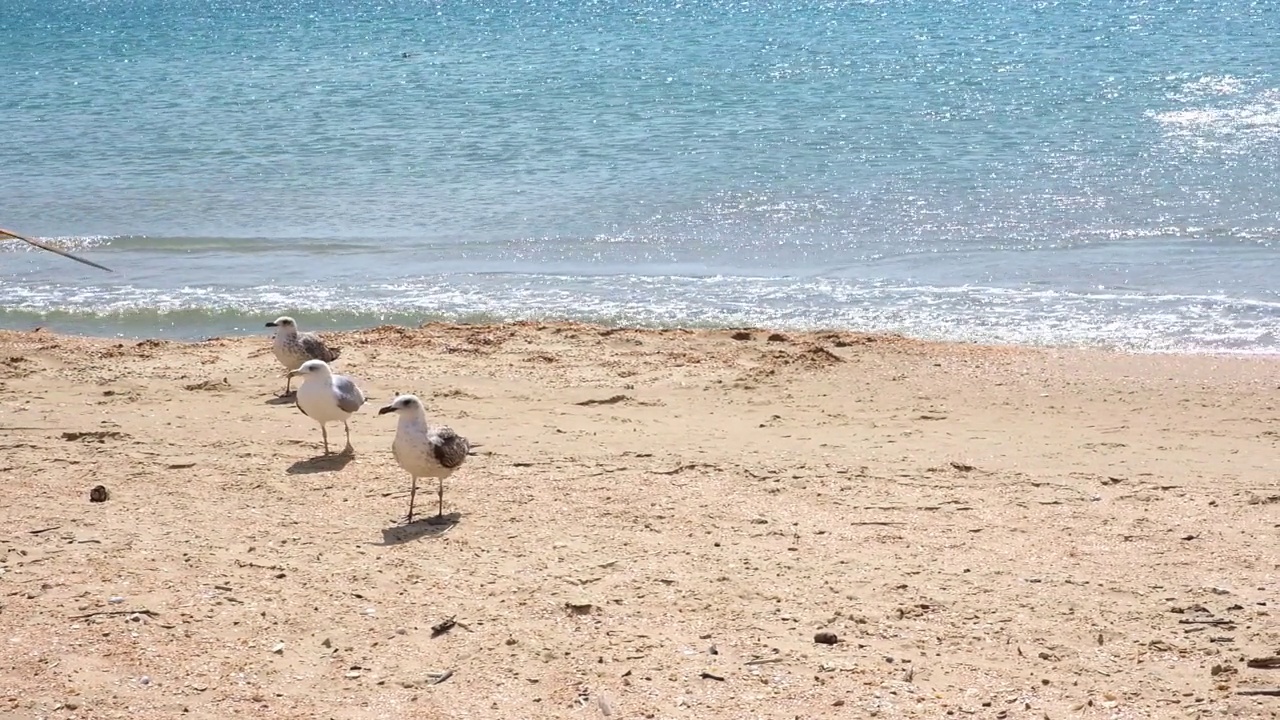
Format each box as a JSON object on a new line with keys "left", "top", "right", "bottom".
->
{"left": 0, "top": 0, "right": 1280, "bottom": 354}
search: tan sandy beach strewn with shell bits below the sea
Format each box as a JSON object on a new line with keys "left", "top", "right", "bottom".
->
{"left": 0, "top": 324, "right": 1280, "bottom": 720}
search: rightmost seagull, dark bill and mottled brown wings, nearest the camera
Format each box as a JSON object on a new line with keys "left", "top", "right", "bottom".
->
{"left": 378, "top": 395, "right": 471, "bottom": 523}
